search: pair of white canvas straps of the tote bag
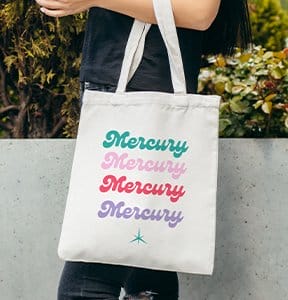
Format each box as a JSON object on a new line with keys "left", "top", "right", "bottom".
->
{"left": 116, "top": 0, "right": 186, "bottom": 94}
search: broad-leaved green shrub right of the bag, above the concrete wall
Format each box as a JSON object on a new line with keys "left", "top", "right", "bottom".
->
{"left": 199, "top": 46, "right": 288, "bottom": 137}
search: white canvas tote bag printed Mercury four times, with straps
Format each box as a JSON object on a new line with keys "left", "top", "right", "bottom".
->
{"left": 58, "top": 0, "right": 220, "bottom": 274}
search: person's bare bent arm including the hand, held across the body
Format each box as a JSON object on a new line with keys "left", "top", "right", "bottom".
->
{"left": 36, "top": 0, "right": 221, "bottom": 30}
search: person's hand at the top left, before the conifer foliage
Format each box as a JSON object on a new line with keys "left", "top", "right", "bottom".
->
{"left": 36, "top": 0, "right": 95, "bottom": 17}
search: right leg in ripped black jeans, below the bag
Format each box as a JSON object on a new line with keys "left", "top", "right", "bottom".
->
{"left": 124, "top": 268, "right": 179, "bottom": 300}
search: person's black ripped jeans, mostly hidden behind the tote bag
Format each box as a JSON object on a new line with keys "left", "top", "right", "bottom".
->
{"left": 57, "top": 83, "right": 178, "bottom": 300}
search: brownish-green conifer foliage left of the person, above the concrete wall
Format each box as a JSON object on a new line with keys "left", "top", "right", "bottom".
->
{"left": 0, "top": 0, "right": 85, "bottom": 138}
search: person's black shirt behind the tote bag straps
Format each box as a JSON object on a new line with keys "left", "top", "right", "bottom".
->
{"left": 80, "top": 7, "right": 203, "bottom": 93}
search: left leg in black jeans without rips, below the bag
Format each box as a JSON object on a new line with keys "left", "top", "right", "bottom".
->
{"left": 57, "top": 261, "right": 131, "bottom": 300}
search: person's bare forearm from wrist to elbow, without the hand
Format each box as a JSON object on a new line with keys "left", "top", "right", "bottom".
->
{"left": 93, "top": 0, "right": 220, "bottom": 30}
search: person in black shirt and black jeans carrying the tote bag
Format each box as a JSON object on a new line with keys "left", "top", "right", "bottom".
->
{"left": 36, "top": 0, "right": 251, "bottom": 300}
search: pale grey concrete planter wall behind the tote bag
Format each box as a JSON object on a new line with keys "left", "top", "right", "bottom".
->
{"left": 0, "top": 139, "right": 288, "bottom": 300}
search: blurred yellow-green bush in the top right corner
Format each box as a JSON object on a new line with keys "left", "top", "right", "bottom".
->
{"left": 249, "top": 0, "right": 288, "bottom": 51}
